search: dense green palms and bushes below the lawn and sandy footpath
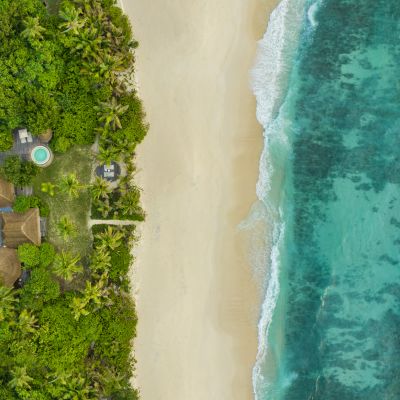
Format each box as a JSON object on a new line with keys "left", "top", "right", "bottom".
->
{"left": 0, "top": 230, "right": 137, "bottom": 400}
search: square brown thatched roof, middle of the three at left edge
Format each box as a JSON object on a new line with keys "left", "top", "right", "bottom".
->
{"left": 1, "top": 208, "right": 41, "bottom": 249}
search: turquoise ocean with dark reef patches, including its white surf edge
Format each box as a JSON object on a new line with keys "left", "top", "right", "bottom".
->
{"left": 247, "top": 0, "right": 400, "bottom": 400}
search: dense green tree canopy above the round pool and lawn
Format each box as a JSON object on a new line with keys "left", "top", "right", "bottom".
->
{"left": 0, "top": 0, "right": 147, "bottom": 152}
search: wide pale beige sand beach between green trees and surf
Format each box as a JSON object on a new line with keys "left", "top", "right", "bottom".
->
{"left": 122, "top": 0, "right": 276, "bottom": 400}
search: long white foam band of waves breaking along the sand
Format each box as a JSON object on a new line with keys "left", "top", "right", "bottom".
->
{"left": 248, "top": 0, "right": 306, "bottom": 400}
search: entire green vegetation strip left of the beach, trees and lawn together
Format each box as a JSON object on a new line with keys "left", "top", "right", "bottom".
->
{"left": 0, "top": 0, "right": 147, "bottom": 400}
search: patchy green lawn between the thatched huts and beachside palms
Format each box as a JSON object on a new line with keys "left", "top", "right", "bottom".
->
{"left": 33, "top": 146, "right": 93, "bottom": 259}
